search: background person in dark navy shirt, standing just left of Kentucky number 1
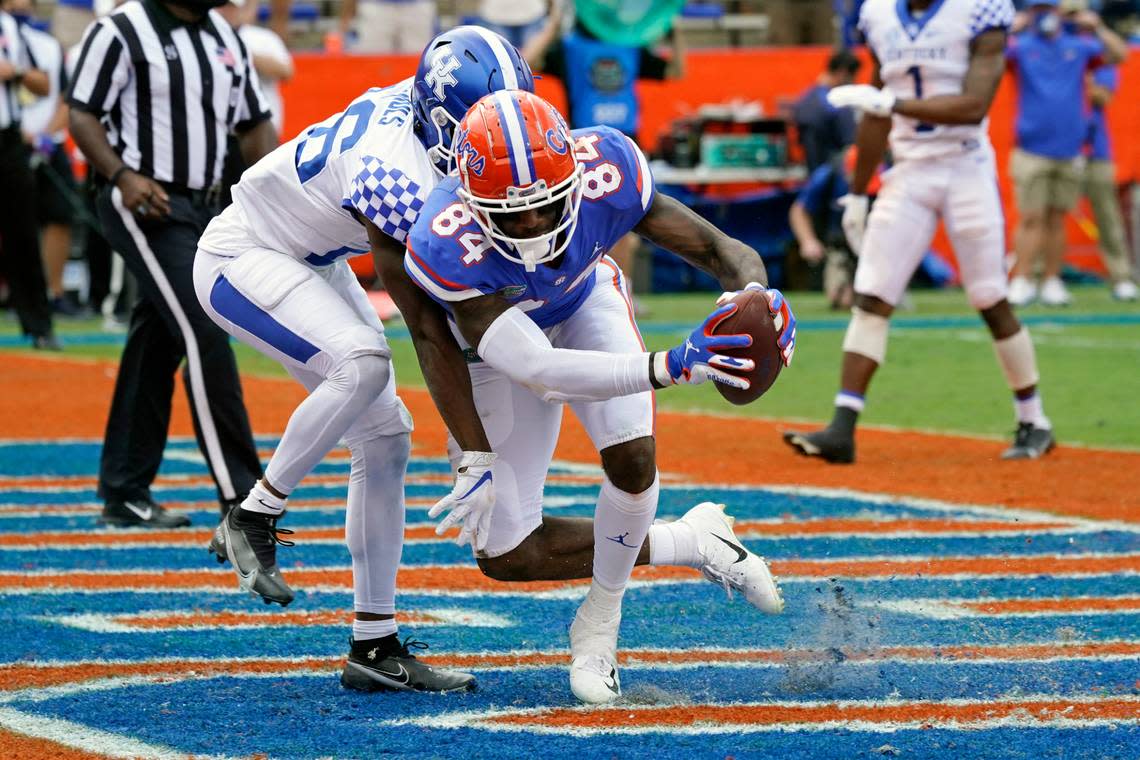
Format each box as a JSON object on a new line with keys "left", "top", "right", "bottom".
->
{"left": 792, "top": 50, "right": 861, "bottom": 172}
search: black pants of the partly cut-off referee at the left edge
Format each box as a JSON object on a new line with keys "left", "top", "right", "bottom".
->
{"left": 0, "top": 126, "right": 51, "bottom": 337}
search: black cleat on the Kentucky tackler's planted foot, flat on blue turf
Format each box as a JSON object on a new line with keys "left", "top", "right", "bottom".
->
{"left": 341, "top": 634, "right": 475, "bottom": 692}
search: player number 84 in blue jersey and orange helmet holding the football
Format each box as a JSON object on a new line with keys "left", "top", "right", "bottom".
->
{"left": 405, "top": 90, "right": 795, "bottom": 703}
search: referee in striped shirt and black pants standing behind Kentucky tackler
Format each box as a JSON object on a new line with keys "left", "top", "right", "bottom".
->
{"left": 67, "top": 0, "right": 277, "bottom": 528}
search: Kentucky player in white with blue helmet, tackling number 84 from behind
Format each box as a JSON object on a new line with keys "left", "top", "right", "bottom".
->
{"left": 194, "top": 26, "right": 534, "bottom": 690}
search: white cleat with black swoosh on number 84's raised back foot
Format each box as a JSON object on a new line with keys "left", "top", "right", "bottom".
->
{"left": 679, "top": 501, "right": 783, "bottom": 615}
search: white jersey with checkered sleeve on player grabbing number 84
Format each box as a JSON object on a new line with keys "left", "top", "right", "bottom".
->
{"left": 198, "top": 79, "right": 439, "bottom": 267}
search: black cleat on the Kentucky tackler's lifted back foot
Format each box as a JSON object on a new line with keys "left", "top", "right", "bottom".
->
{"left": 210, "top": 507, "right": 294, "bottom": 607}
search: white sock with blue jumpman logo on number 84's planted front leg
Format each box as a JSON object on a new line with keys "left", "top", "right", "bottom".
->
{"left": 594, "top": 473, "right": 660, "bottom": 590}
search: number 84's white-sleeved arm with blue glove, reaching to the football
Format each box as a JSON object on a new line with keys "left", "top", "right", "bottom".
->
{"left": 451, "top": 288, "right": 754, "bottom": 401}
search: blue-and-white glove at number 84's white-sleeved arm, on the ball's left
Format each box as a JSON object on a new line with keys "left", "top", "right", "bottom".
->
{"left": 653, "top": 303, "right": 755, "bottom": 390}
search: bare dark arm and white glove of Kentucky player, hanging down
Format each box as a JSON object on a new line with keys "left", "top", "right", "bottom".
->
{"left": 364, "top": 221, "right": 496, "bottom": 551}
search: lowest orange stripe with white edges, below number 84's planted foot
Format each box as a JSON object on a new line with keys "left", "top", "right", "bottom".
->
{"left": 494, "top": 697, "right": 1140, "bottom": 729}
